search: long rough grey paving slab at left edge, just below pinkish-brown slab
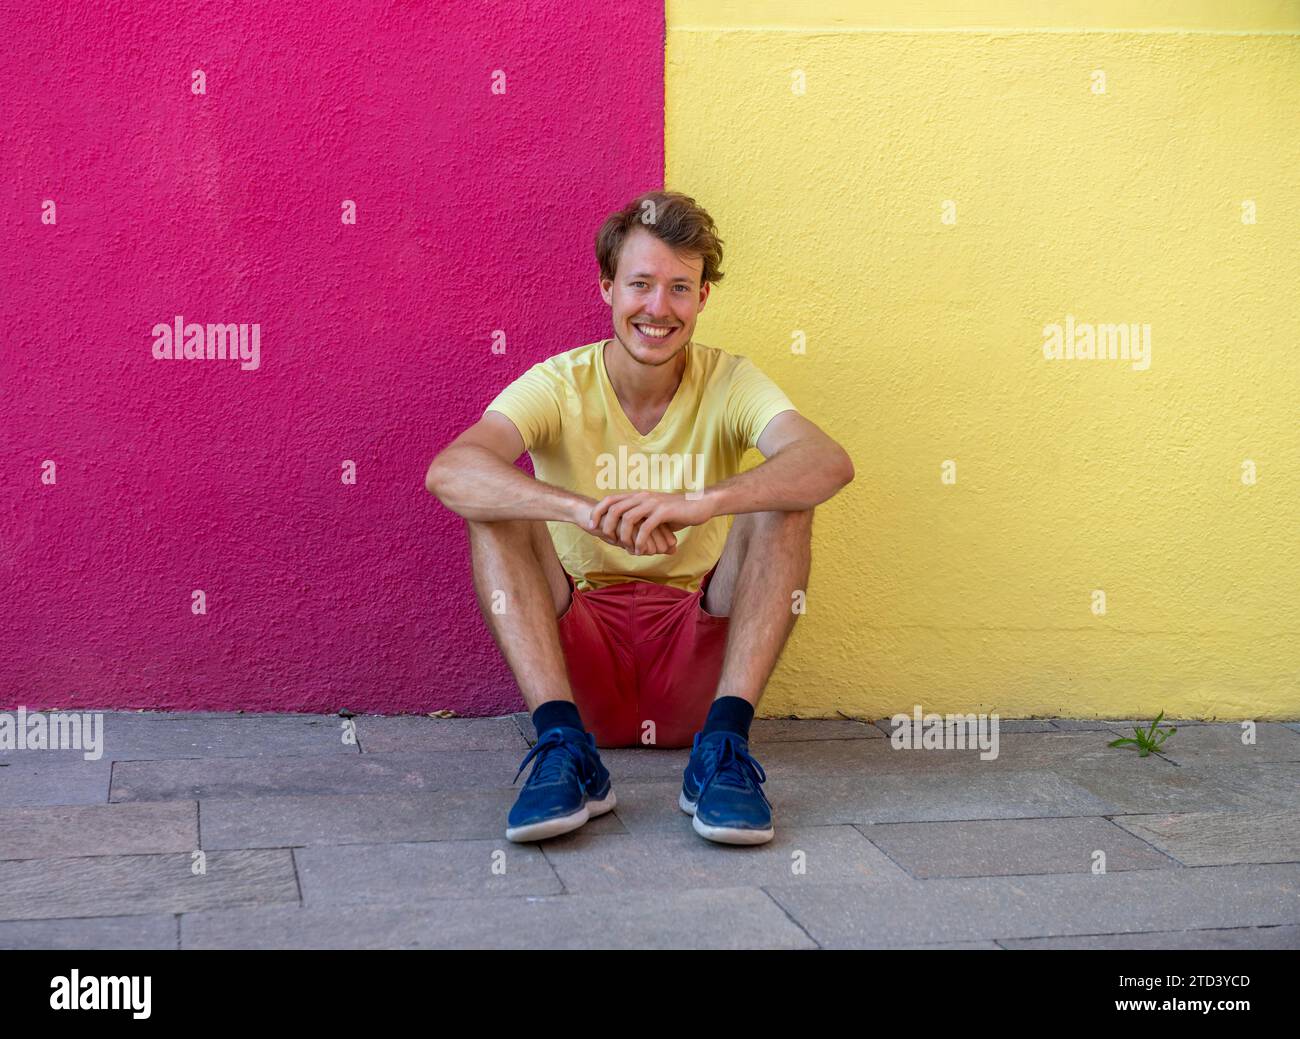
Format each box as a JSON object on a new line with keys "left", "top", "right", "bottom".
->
{"left": 0, "top": 850, "right": 299, "bottom": 919}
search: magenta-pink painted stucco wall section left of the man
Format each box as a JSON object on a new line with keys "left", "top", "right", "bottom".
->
{"left": 0, "top": 0, "right": 663, "bottom": 715}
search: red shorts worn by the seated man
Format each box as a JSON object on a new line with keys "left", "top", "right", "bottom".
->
{"left": 558, "top": 567, "right": 729, "bottom": 748}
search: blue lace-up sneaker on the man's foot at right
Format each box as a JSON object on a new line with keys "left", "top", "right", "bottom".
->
{"left": 677, "top": 732, "right": 776, "bottom": 844}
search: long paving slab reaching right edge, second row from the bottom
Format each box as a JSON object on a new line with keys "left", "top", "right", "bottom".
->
{"left": 759, "top": 863, "right": 1300, "bottom": 948}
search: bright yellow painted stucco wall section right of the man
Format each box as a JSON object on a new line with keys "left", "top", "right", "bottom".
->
{"left": 666, "top": 0, "right": 1300, "bottom": 719}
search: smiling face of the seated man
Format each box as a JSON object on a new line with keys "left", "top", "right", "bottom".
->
{"left": 601, "top": 228, "right": 710, "bottom": 365}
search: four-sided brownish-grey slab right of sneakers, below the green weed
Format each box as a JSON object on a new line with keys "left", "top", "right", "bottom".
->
{"left": 858, "top": 818, "right": 1185, "bottom": 879}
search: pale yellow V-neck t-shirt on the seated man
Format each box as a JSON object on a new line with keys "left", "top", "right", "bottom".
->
{"left": 484, "top": 339, "right": 797, "bottom": 592}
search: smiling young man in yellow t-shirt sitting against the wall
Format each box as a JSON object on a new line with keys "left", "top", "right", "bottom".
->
{"left": 425, "top": 191, "right": 853, "bottom": 844}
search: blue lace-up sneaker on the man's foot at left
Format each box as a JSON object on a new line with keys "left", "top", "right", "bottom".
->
{"left": 506, "top": 726, "right": 618, "bottom": 841}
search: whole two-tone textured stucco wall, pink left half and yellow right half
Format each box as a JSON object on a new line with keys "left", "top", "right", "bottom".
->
{"left": 0, "top": 0, "right": 1300, "bottom": 718}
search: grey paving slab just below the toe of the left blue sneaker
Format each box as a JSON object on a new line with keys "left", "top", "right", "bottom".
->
{"left": 294, "top": 832, "right": 564, "bottom": 906}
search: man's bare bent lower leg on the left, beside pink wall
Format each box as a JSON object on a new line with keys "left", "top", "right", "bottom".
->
{"left": 465, "top": 520, "right": 573, "bottom": 714}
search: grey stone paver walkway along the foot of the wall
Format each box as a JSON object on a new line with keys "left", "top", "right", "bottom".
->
{"left": 0, "top": 713, "right": 1300, "bottom": 949}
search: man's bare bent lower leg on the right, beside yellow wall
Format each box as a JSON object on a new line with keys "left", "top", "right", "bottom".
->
{"left": 703, "top": 508, "right": 813, "bottom": 707}
